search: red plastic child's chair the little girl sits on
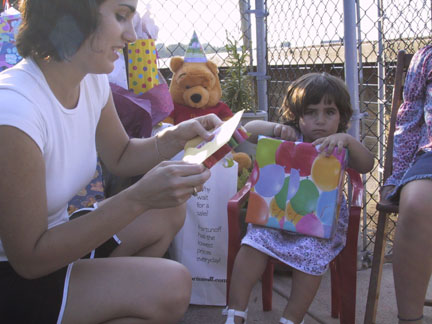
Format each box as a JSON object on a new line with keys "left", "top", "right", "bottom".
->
{"left": 227, "top": 168, "right": 363, "bottom": 324}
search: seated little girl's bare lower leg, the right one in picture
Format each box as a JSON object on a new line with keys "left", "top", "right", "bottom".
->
{"left": 283, "top": 269, "right": 322, "bottom": 324}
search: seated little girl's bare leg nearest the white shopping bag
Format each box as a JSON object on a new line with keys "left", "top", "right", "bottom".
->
{"left": 228, "top": 245, "right": 268, "bottom": 323}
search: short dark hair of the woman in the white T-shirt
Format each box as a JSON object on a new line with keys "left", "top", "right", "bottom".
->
{"left": 16, "top": 0, "right": 105, "bottom": 61}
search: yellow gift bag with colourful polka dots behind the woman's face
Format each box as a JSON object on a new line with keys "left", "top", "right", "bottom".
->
{"left": 128, "top": 39, "right": 160, "bottom": 95}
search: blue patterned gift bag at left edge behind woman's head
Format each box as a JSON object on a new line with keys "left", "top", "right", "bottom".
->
{"left": 0, "top": 5, "right": 22, "bottom": 71}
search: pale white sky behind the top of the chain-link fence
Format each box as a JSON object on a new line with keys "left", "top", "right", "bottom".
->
{"left": 139, "top": 0, "right": 431, "bottom": 47}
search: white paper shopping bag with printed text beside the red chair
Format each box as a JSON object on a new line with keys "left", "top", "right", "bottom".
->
{"left": 170, "top": 159, "right": 238, "bottom": 306}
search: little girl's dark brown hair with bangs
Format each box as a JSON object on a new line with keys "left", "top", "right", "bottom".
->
{"left": 280, "top": 72, "right": 353, "bottom": 133}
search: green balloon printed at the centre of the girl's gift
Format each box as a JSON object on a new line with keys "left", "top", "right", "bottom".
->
{"left": 290, "top": 179, "right": 319, "bottom": 215}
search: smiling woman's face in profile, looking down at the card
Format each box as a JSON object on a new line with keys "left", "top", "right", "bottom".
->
{"left": 77, "top": 0, "right": 138, "bottom": 74}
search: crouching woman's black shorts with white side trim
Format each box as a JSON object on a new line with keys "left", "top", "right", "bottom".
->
{"left": 0, "top": 209, "right": 120, "bottom": 324}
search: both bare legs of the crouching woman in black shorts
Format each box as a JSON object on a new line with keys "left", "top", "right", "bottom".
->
{"left": 63, "top": 202, "right": 192, "bottom": 324}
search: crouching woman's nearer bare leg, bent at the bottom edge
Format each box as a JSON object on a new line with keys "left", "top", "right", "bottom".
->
{"left": 62, "top": 257, "right": 192, "bottom": 324}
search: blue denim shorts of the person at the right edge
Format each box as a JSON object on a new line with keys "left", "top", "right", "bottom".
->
{"left": 388, "top": 152, "right": 432, "bottom": 202}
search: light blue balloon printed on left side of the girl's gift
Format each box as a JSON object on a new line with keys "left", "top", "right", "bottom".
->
{"left": 255, "top": 164, "right": 285, "bottom": 197}
